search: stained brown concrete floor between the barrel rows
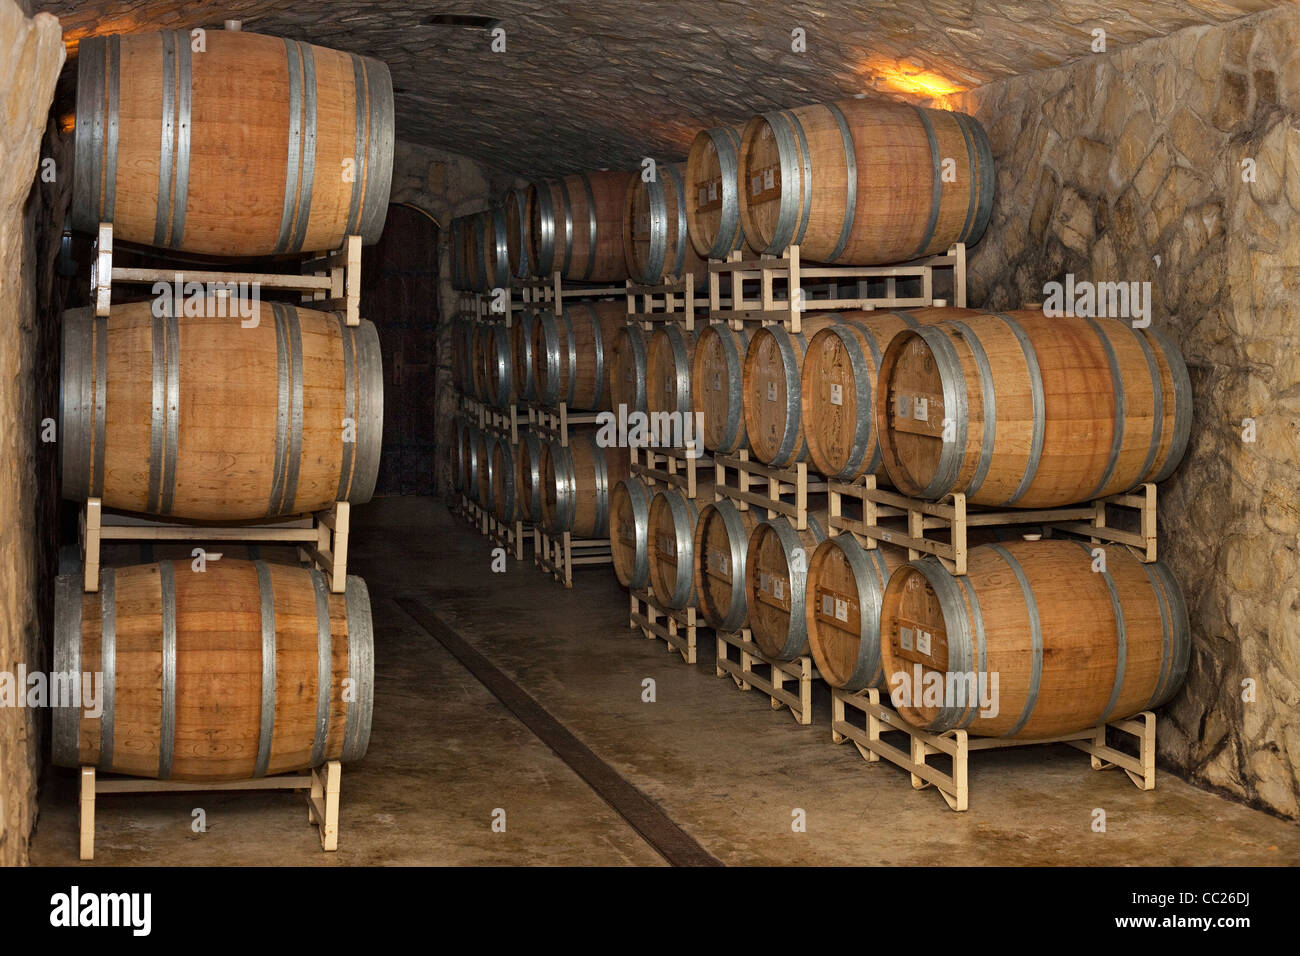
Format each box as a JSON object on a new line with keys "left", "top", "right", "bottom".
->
{"left": 31, "top": 498, "right": 1300, "bottom": 865}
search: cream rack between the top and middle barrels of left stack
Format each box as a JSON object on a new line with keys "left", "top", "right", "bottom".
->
{"left": 91, "top": 222, "right": 361, "bottom": 325}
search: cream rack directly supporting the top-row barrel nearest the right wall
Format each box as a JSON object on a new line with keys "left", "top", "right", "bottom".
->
{"left": 709, "top": 243, "right": 966, "bottom": 333}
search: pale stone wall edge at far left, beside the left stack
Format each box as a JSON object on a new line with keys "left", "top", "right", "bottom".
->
{"left": 0, "top": 0, "right": 64, "bottom": 865}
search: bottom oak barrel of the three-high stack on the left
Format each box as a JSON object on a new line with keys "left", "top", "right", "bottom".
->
{"left": 52, "top": 558, "right": 374, "bottom": 782}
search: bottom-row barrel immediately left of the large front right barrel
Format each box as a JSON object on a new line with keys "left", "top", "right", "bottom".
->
{"left": 805, "top": 533, "right": 907, "bottom": 691}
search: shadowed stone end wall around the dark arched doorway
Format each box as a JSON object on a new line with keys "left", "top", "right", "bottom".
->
{"left": 390, "top": 140, "right": 516, "bottom": 494}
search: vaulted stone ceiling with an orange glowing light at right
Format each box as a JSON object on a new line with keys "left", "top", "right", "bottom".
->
{"left": 33, "top": 0, "right": 1279, "bottom": 176}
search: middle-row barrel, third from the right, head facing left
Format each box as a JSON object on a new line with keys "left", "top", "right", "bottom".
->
{"left": 741, "top": 312, "right": 842, "bottom": 467}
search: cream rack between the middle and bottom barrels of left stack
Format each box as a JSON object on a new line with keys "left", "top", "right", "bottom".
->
{"left": 82, "top": 498, "right": 352, "bottom": 594}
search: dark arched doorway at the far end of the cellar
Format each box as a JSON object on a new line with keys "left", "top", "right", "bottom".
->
{"left": 361, "top": 204, "right": 438, "bottom": 494}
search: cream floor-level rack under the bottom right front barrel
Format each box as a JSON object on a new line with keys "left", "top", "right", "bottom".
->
{"left": 831, "top": 688, "right": 1156, "bottom": 812}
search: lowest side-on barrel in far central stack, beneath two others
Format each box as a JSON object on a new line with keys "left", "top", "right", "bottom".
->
{"left": 540, "top": 431, "right": 631, "bottom": 538}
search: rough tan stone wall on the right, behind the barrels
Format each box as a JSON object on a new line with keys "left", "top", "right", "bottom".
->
{"left": 945, "top": 7, "right": 1300, "bottom": 817}
